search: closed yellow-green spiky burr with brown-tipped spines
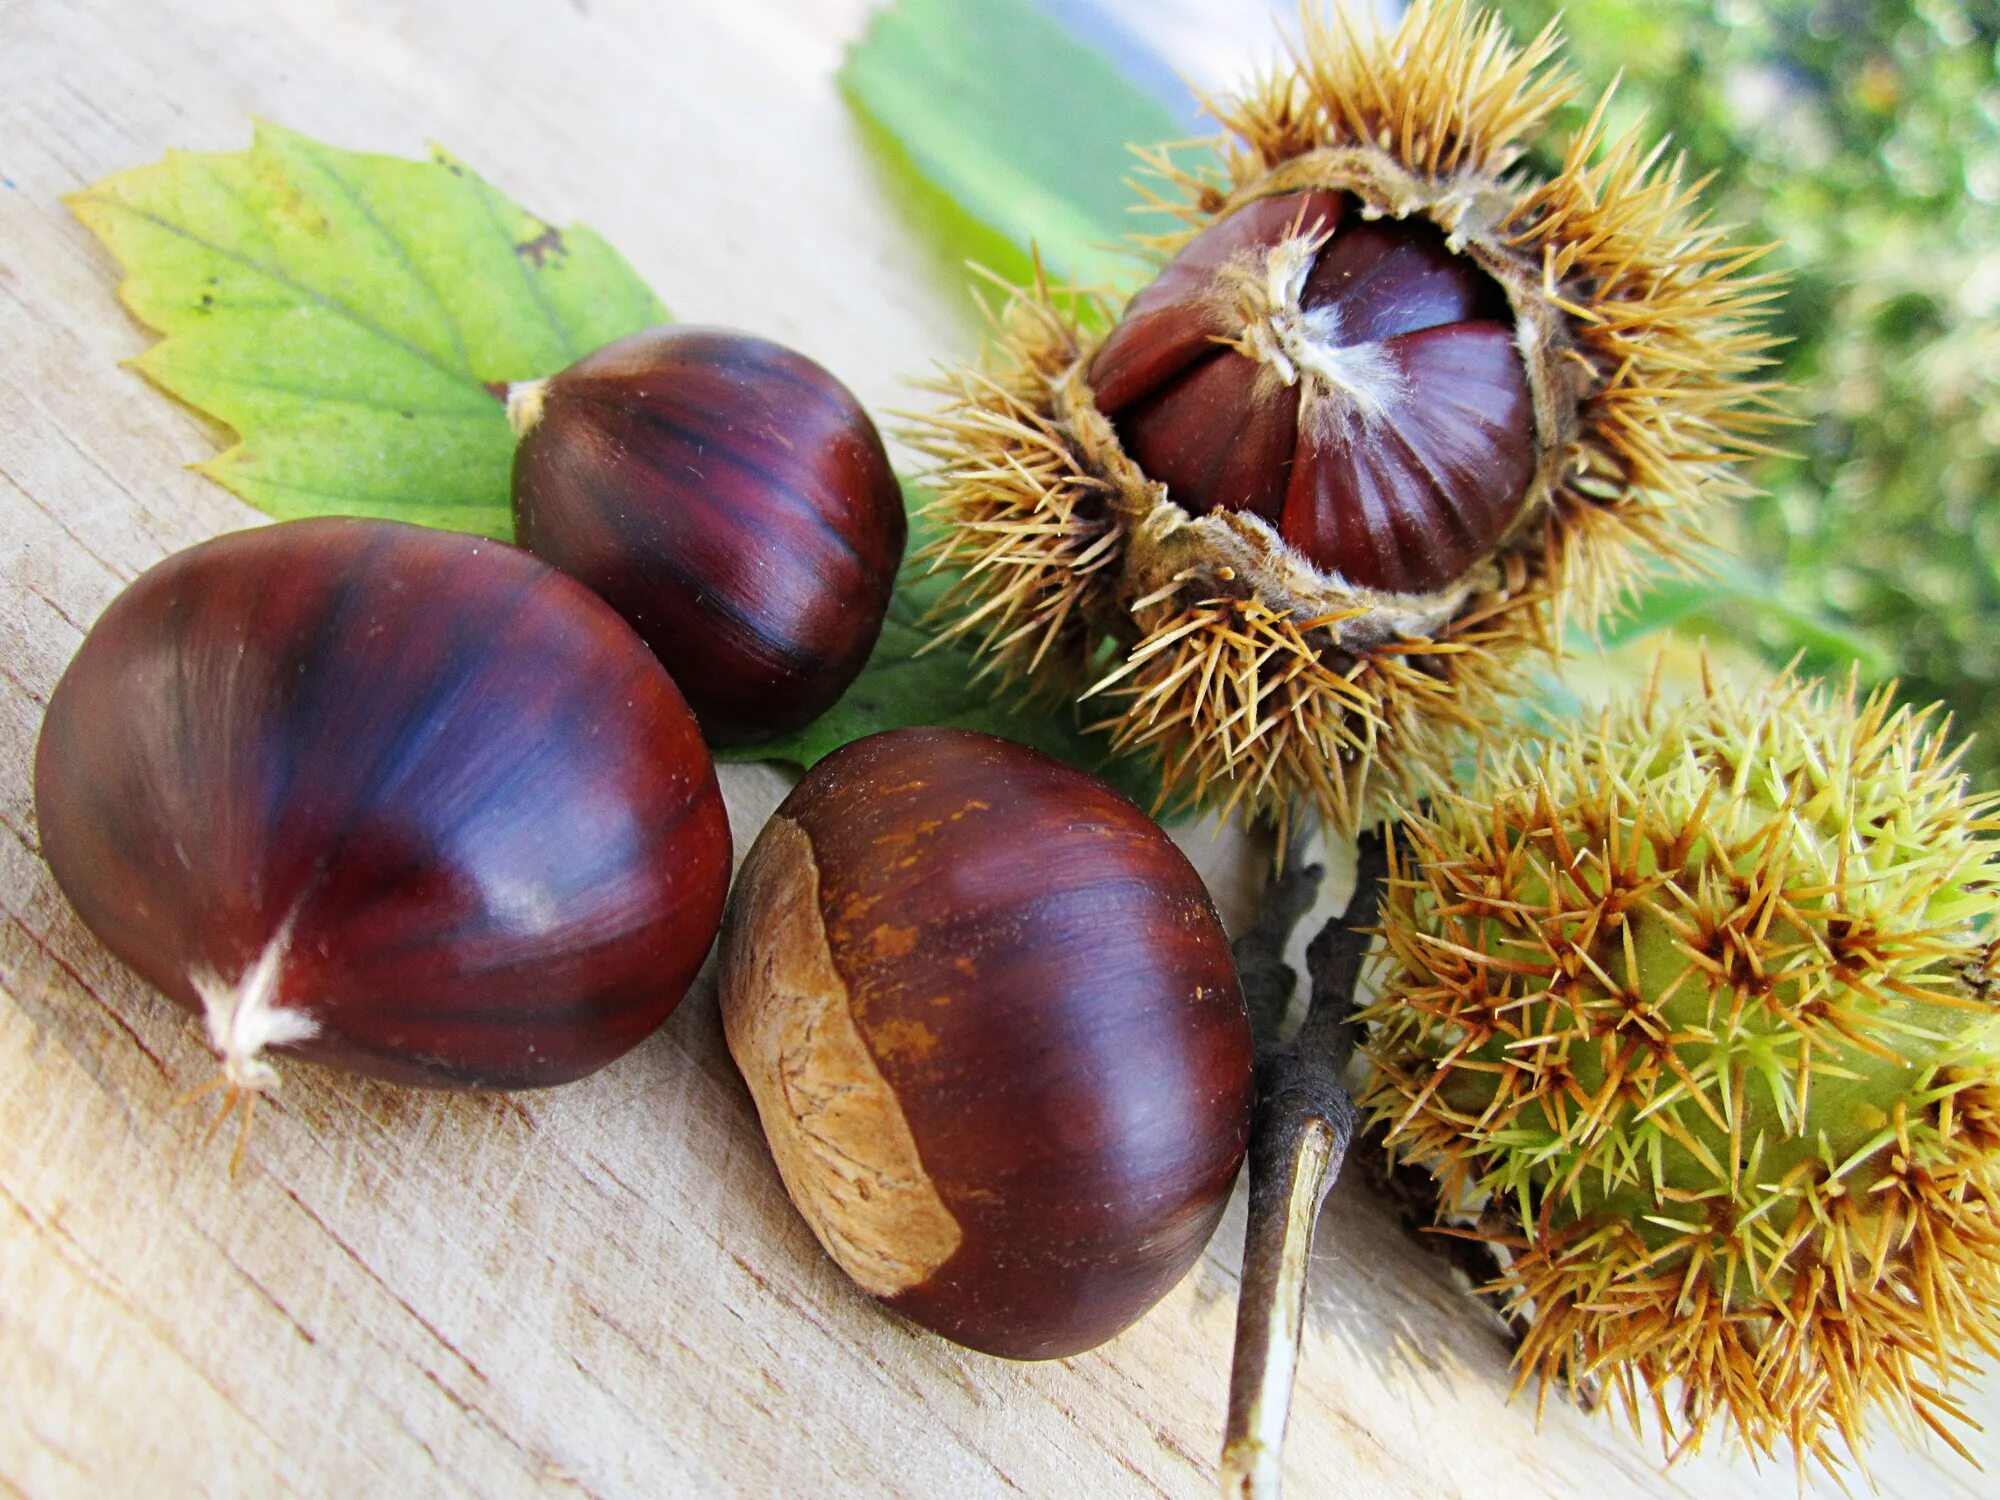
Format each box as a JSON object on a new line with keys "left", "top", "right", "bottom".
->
{"left": 1362, "top": 664, "right": 2000, "bottom": 1468}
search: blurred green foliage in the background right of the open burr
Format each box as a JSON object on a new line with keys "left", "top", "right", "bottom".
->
{"left": 1498, "top": 0, "right": 2000, "bottom": 786}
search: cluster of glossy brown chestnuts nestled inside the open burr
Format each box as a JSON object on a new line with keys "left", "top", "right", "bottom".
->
{"left": 1090, "top": 190, "right": 1534, "bottom": 594}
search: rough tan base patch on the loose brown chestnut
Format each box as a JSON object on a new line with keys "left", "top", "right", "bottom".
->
{"left": 720, "top": 818, "right": 964, "bottom": 1298}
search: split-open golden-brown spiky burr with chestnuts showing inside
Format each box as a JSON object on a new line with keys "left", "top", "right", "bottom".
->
{"left": 918, "top": 0, "right": 1774, "bottom": 830}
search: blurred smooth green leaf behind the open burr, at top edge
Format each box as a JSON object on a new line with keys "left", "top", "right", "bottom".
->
{"left": 840, "top": 0, "right": 1184, "bottom": 294}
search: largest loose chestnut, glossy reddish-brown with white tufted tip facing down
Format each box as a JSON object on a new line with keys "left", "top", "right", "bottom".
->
{"left": 34, "top": 520, "right": 730, "bottom": 1088}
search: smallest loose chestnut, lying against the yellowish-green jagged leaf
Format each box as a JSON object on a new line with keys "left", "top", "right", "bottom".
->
{"left": 508, "top": 326, "right": 908, "bottom": 744}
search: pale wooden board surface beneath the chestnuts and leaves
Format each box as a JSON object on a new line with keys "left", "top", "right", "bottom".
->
{"left": 0, "top": 0, "right": 2000, "bottom": 1500}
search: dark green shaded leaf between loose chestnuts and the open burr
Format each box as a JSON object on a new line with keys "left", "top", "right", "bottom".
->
{"left": 716, "top": 488, "right": 1160, "bottom": 808}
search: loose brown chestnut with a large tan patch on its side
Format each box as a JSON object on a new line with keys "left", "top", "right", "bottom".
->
{"left": 720, "top": 730, "right": 1252, "bottom": 1360}
